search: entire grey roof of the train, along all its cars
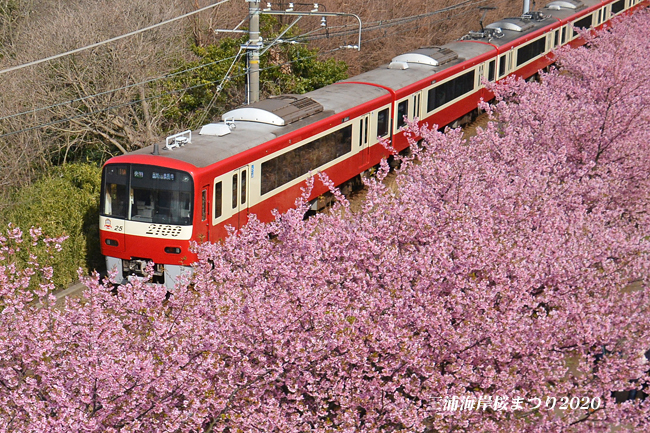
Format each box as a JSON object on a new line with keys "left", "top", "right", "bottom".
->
{"left": 117, "top": 0, "right": 601, "bottom": 168}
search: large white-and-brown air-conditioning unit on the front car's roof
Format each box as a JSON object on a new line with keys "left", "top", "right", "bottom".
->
{"left": 222, "top": 95, "right": 323, "bottom": 126}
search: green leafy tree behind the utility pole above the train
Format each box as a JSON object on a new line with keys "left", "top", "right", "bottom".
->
{"left": 160, "top": 16, "right": 347, "bottom": 129}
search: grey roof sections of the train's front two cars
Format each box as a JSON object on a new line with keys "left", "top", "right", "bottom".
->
{"left": 128, "top": 37, "right": 494, "bottom": 168}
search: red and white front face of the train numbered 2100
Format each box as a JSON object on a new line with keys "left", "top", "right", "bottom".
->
{"left": 99, "top": 156, "right": 197, "bottom": 289}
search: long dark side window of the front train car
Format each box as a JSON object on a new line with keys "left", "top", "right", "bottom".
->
{"left": 261, "top": 125, "right": 352, "bottom": 194}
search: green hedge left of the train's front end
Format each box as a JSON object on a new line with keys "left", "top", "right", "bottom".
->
{"left": 0, "top": 164, "right": 104, "bottom": 287}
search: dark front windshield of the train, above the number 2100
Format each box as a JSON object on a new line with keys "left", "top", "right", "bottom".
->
{"left": 100, "top": 164, "right": 193, "bottom": 225}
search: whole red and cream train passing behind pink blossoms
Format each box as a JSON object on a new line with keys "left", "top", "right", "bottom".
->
{"left": 99, "top": 0, "right": 650, "bottom": 289}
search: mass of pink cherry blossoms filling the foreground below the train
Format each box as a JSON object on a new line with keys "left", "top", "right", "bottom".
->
{"left": 0, "top": 7, "right": 650, "bottom": 432}
